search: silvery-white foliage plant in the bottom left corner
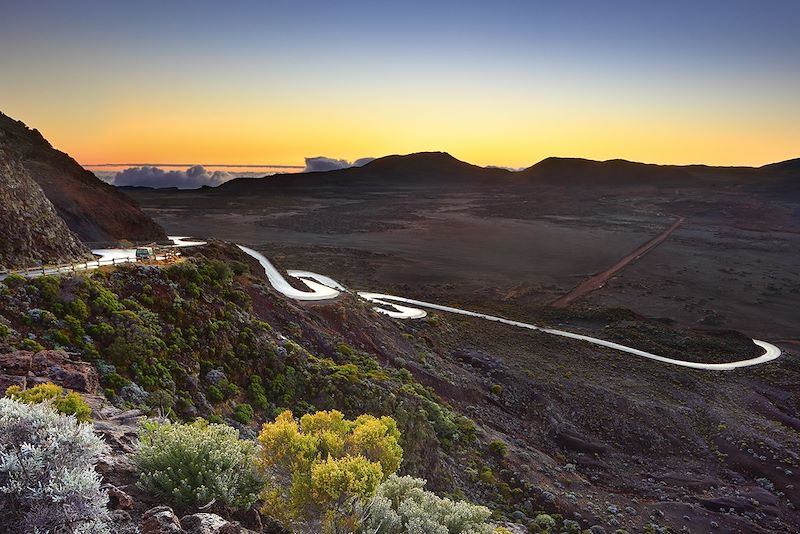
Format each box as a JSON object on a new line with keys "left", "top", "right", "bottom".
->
{"left": 0, "top": 398, "right": 110, "bottom": 534}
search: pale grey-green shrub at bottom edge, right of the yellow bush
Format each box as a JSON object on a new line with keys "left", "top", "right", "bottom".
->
{"left": 355, "top": 475, "right": 497, "bottom": 534}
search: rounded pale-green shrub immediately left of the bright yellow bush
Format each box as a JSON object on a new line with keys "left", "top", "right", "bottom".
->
{"left": 135, "top": 419, "right": 261, "bottom": 511}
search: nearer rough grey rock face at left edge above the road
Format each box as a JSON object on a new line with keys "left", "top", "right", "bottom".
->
{"left": 0, "top": 129, "right": 90, "bottom": 268}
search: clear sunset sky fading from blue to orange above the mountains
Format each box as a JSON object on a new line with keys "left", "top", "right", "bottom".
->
{"left": 0, "top": 0, "right": 800, "bottom": 171}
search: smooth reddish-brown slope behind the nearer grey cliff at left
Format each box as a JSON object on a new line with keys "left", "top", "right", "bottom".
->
{"left": 0, "top": 113, "right": 166, "bottom": 246}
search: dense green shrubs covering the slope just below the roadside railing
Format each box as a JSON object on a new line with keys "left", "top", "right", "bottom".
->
{"left": 0, "top": 256, "right": 475, "bottom": 494}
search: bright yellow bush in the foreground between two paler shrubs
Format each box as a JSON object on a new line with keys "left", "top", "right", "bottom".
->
{"left": 258, "top": 410, "right": 403, "bottom": 521}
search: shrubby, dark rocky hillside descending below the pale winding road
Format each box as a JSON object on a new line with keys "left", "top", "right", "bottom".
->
{"left": 0, "top": 243, "right": 800, "bottom": 534}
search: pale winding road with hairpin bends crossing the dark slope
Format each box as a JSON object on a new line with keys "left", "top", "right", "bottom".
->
{"left": 0, "top": 236, "right": 781, "bottom": 371}
